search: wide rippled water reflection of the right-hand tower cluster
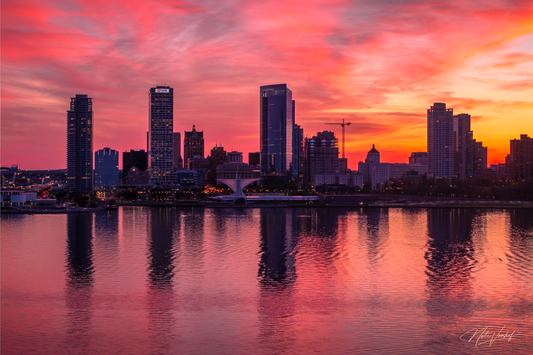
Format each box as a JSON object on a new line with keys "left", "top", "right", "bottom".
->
{"left": 425, "top": 208, "right": 479, "bottom": 353}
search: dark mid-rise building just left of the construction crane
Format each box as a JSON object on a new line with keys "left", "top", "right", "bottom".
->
{"left": 304, "top": 131, "right": 340, "bottom": 184}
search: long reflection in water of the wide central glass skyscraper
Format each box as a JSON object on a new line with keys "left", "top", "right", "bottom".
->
{"left": 257, "top": 208, "right": 296, "bottom": 354}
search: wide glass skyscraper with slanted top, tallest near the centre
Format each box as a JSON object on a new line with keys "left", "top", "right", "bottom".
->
{"left": 259, "top": 84, "right": 294, "bottom": 179}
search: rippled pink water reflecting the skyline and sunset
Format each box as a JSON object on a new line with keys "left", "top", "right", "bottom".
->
{"left": 1, "top": 207, "right": 533, "bottom": 354}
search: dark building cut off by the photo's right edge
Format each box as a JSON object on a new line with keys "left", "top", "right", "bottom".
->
{"left": 506, "top": 134, "right": 533, "bottom": 180}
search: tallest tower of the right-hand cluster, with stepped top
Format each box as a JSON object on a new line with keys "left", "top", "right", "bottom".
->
{"left": 427, "top": 102, "right": 455, "bottom": 178}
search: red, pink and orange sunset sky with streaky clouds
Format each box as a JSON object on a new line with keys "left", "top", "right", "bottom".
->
{"left": 1, "top": 0, "right": 533, "bottom": 169}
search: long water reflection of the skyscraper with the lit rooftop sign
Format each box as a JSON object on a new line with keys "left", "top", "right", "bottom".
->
{"left": 147, "top": 207, "right": 180, "bottom": 353}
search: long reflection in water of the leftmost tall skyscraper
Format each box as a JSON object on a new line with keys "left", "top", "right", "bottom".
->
{"left": 65, "top": 213, "right": 94, "bottom": 352}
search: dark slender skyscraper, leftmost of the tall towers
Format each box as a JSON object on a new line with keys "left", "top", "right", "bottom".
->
{"left": 67, "top": 95, "right": 93, "bottom": 195}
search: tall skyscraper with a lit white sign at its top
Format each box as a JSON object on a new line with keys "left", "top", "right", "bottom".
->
{"left": 148, "top": 86, "right": 174, "bottom": 184}
